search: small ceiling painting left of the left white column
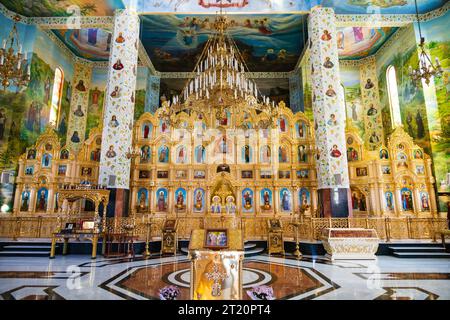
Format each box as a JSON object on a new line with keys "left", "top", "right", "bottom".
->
{"left": 52, "top": 29, "right": 111, "bottom": 61}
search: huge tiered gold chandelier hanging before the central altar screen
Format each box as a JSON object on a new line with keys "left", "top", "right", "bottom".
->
{"left": 159, "top": 13, "right": 279, "bottom": 129}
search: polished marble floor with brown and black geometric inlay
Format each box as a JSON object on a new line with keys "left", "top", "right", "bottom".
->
{"left": 0, "top": 255, "right": 450, "bottom": 300}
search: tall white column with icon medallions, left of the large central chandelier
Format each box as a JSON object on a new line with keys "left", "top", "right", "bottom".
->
{"left": 98, "top": 10, "right": 139, "bottom": 216}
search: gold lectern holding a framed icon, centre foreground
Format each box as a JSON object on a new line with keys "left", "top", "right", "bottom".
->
{"left": 189, "top": 229, "right": 244, "bottom": 300}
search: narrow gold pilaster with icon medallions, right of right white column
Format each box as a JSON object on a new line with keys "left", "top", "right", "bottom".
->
{"left": 359, "top": 56, "right": 384, "bottom": 150}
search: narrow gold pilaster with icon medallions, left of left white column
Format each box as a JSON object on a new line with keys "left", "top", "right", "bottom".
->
{"left": 66, "top": 60, "right": 92, "bottom": 152}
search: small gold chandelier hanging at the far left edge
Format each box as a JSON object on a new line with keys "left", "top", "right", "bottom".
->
{"left": 0, "top": 16, "right": 30, "bottom": 90}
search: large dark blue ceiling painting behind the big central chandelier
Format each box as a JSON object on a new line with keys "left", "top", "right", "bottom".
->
{"left": 141, "top": 14, "right": 307, "bottom": 72}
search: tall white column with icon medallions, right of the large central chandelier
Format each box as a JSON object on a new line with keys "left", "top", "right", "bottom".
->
{"left": 308, "top": 7, "right": 351, "bottom": 217}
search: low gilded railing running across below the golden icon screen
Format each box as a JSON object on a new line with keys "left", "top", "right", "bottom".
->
{"left": 0, "top": 216, "right": 447, "bottom": 241}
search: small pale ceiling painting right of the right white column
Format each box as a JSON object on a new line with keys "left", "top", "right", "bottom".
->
{"left": 337, "top": 27, "right": 398, "bottom": 60}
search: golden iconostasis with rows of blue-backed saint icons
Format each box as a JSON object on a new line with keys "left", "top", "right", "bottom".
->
{"left": 14, "top": 102, "right": 437, "bottom": 217}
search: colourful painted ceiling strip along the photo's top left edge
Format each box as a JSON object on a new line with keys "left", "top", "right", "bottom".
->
{"left": 0, "top": 0, "right": 125, "bottom": 17}
